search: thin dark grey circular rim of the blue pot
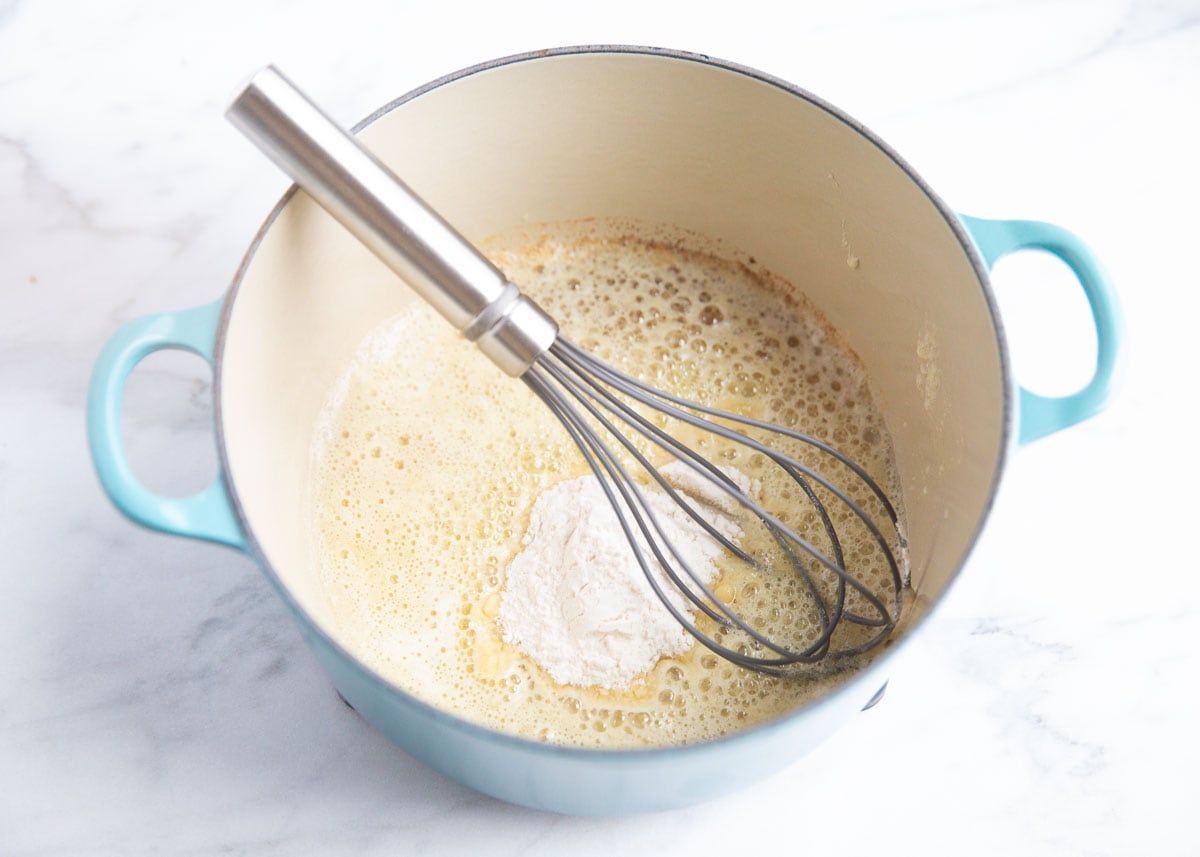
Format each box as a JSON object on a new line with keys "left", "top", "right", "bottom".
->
{"left": 212, "top": 44, "right": 1014, "bottom": 760}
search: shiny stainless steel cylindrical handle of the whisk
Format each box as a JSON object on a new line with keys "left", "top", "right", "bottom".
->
{"left": 226, "top": 66, "right": 558, "bottom": 377}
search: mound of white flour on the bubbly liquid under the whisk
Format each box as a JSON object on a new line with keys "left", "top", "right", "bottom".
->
{"left": 499, "top": 461, "right": 758, "bottom": 689}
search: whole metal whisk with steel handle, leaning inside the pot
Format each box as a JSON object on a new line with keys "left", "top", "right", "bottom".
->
{"left": 227, "top": 66, "right": 904, "bottom": 676}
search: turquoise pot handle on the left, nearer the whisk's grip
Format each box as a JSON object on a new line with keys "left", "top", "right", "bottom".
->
{"left": 88, "top": 300, "right": 246, "bottom": 551}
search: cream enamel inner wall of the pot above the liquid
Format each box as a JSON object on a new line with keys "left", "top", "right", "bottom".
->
{"left": 220, "top": 53, "right": 1006, "bottom": 652}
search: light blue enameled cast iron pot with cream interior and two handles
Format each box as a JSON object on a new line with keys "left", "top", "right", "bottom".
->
{"left": 88, "top": 47, "right": 1120, "bottom": 814}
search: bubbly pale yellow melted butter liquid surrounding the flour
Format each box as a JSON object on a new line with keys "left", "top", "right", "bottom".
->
{"left": 312, "top": 222, "right": 896, "bottom": 748}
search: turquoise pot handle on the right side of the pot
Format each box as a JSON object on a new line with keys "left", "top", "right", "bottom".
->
{"left": 959, "top": 215, "right": 1123, "bottom": 444}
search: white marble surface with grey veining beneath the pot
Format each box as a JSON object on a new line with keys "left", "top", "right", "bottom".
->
{"left": 0, "top": 0, "right": 1200, "bottom": 857}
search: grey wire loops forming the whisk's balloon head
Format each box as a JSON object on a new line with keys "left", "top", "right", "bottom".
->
{"left": 523, "top": 335, "right": 904, "bottom": 676}
